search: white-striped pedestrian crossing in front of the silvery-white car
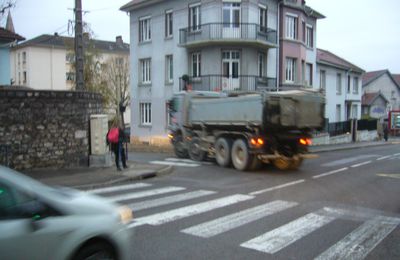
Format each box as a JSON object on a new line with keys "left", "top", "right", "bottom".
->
{"left": 88, "top": 183, "right": 400, "bottom": 260}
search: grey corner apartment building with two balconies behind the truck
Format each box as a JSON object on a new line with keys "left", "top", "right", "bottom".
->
{"left": 121, "top": 0, "right": 279, "bottom": 142}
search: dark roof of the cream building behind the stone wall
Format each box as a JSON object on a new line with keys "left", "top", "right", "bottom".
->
{"left": 14, "top": 34, "right": 129, "bottom": 52}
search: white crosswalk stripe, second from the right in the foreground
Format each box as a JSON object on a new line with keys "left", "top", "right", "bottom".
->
{"left": 240, "top": 213, "right": 335, "bottom": 254}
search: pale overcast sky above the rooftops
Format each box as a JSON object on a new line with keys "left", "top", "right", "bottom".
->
{"left": 3, "top": 0, "right": 400, "bottom": 74}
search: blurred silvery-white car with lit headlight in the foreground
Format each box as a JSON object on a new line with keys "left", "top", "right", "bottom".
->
{"left": 0, "top": 166, "right": 133, "bottom": 260}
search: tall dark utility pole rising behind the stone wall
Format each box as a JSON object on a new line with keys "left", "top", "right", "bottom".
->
{"left": 75, "top": 0, "right": 85, "bottom": 91}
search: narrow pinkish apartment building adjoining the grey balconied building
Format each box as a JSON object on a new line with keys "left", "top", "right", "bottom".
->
{"left": 279, "top": 0, "right": 325, "bottom": 90}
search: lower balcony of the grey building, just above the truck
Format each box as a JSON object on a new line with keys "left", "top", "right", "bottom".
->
{"left": 179, "top": 75, "right": 276, "bottom": 92}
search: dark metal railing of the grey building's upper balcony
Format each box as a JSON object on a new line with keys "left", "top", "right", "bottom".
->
{"left": 179, "top": 23, "right": 277, "bottom": 45}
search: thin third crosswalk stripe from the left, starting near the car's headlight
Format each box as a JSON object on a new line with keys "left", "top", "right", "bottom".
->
{"left": 128, "top": 190, "right": 216, "bottom": 211}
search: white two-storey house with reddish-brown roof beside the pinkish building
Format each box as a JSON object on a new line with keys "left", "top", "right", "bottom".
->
{"left": 314, "top": 49, "right": 365, "bottom": 123}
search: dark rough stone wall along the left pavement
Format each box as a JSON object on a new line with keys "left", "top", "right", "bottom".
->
{"left": 0, "top": 88, "right": 103, "bottom": 169}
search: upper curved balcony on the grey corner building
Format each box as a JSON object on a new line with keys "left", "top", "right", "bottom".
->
{"left": 179, "top": 23, "right": 277, "bottom": 48}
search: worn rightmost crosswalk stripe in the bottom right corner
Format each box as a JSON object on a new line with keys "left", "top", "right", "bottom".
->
{"left": 316, "top": 216, "right": 400, "bottom": 260}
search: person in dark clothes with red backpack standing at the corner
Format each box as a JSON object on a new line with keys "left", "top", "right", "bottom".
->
{"left": 106, "top": 123, "right": 128, "bottom": 171}
